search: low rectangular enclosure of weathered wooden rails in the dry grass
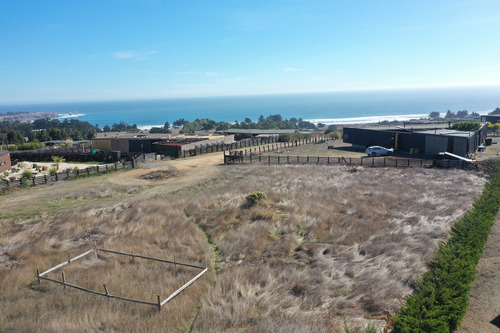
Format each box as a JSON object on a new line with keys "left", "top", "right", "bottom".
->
{"left": 36, "top": 242, "right": 208, "bottom": 311}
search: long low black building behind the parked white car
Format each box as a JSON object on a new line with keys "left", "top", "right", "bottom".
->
{"left": 343, "top": 124, "right": 488, "bottom": 156}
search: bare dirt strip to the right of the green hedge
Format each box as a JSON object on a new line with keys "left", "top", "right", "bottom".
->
{"left": 456, "top": 214, "right": 500, "bottom": 333}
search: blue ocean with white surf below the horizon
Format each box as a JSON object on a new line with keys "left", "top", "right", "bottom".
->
{"left": 0, "top": 87, "right": 500, "bottom": 129}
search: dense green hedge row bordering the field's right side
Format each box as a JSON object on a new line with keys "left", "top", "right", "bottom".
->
{"left": 393, "top": 163, "right": 500, "bottom": 332}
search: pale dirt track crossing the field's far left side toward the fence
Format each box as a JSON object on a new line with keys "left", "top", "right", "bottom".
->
{"left": 0, "top": 153, "right": 224, "bottom": 221}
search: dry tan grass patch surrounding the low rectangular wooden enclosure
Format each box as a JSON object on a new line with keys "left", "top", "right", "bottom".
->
{"left": 0, "top": 196, "right": 214, "bottom": 331}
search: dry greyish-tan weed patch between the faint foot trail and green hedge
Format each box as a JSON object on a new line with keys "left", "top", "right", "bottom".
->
{"left": 186, "top": 166, "right": 485, "bottom": 332}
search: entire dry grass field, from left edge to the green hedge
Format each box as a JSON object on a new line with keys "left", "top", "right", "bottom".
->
{"left": 0, "top": 154, "right": 485, "bottom": 332}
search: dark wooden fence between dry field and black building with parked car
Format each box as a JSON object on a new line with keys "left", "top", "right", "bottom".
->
{"left": 224, "top": 152, "right": 433, "bottom": 168}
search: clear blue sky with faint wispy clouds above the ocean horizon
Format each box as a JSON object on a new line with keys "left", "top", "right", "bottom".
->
{"left": 0, "top": 0, "right": 500, "bottom": 104}
